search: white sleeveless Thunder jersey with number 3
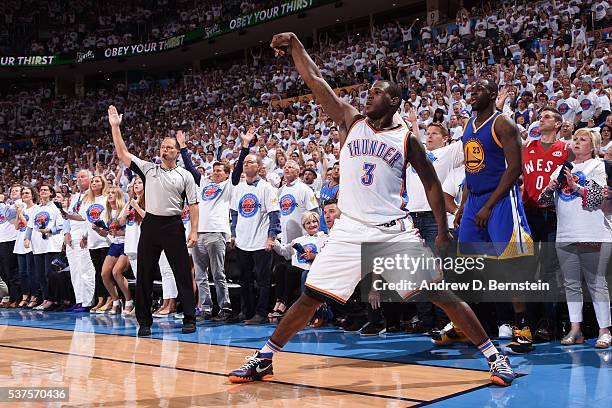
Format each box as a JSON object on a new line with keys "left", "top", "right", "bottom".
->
{"left": 338, "top": 118, "right": 410, "bottom": 225}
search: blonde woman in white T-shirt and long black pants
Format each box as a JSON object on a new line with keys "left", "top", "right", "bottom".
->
{"left": 79, "top": 175, "right": 109, "bottom": 313}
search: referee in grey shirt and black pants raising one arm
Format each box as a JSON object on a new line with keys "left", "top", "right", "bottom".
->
{"left": 108, "top": 106, "right": 198, "bottom": 336}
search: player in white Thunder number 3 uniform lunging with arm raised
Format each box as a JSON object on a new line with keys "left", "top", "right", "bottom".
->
{"left": 229, "top": 33, "right": 514, "bottom": 386}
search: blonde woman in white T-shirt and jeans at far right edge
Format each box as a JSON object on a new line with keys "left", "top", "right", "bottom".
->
{"left": 540, "top": 128, "right": 612, "bottom": 348}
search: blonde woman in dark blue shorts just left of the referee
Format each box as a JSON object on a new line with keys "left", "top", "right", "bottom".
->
{"left": 96, "top": 186, "right": 129, "bottom": 314}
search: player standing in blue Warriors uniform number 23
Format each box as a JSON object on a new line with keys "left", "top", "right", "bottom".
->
{"left": 455, "top": 79, "right": 533, "bottom": 353}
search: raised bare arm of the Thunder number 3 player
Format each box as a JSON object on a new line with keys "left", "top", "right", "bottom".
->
{"left": 270, "top": 33, "right": 359, "bottom": 145}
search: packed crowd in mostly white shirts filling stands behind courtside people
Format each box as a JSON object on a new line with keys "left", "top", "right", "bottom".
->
{"left": 0, "top": 0, "right": 612, "bottom": 344}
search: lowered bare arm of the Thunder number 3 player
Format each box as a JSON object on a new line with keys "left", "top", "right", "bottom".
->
{"left": 406, "top": 133, "right": 451, "bottom": 251}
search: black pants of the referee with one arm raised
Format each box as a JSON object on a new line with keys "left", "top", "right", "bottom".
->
{"left": 135, "top": 213, "right": 195, "bottom": 326}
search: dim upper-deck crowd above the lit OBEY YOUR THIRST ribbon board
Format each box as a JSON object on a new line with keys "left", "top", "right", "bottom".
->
{"left": 0, "top": 0, "right": 272, "bottom": 55}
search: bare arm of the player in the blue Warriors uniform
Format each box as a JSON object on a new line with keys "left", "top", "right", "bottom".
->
{"left": 476, "top": 115, "right": 523, "bottom": 228}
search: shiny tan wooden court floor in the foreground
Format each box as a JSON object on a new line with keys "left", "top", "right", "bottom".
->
{"left": 0, "top": 326, "right": 489, "bottom": 407}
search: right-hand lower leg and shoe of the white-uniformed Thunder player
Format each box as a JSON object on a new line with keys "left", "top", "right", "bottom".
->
{"left": 428, "top": 291, "right": 515, "bottom": 386}
